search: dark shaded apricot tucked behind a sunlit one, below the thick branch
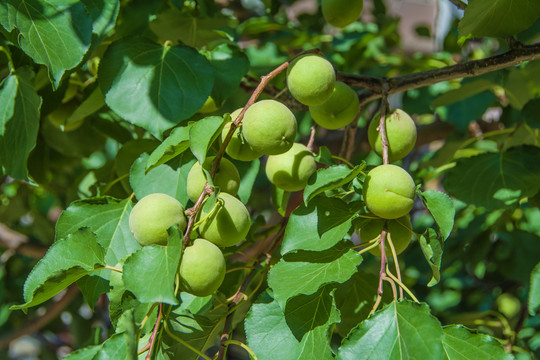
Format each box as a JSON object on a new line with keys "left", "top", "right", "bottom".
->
{"left": 309, "top": 81, "right": 360, "bottom": 130}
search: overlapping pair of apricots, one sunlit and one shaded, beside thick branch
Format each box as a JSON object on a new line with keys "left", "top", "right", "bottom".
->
{"left": 287, "top": 54, "right": 360, "bottom": 130}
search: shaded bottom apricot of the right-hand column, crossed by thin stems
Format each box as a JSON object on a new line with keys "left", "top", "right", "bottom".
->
{"left": 360, "top": 215, "right": 412, "bottom": 257}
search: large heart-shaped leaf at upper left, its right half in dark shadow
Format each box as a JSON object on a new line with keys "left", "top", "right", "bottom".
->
{"left": 99, "top": 37, "right": 214, "bottom": 138}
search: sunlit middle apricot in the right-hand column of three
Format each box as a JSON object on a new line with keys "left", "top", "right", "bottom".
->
{"left": 363, "top": 165, "right": 416, "bottom": 219}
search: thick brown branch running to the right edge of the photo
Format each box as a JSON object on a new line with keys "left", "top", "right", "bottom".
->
{"left": 338, "top": 44, "right": 540, "bottom": 105}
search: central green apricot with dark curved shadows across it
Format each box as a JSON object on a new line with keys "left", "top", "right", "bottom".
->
{"left": 266, "top": 143, "right": 317, "bottom": 191}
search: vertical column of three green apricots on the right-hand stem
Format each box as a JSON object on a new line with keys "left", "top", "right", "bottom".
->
{"left": 360, "top": 109, "right": 416, "bottom": 256}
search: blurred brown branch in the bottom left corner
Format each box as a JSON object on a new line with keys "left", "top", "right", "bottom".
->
{"left": 0, "top": 284, "right": 79, "bottom": 349}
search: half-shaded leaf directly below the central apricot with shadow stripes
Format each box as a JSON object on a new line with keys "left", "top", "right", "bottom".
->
{"left": 281, "top": 196, "right": 362, "bottom": 254}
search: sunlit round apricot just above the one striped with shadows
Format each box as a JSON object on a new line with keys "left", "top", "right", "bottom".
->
{"left": 242, "top": 100, "right": 297, "bottom": 155}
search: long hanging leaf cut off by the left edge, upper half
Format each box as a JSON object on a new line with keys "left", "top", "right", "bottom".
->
{"left": 0, "top": 67, "right": 41, "bottom": 180}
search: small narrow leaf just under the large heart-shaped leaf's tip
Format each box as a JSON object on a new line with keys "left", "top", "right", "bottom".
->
{"left": 146, "top": 125, "right": 190, "bottom": 172}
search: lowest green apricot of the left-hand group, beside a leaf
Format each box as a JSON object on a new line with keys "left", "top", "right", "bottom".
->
{"left": 179, "top": 239, "right": 226, "bottom": 296}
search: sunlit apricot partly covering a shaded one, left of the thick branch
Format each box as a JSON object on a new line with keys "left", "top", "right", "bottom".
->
{"left": 287, "top": 54, "right": 336, "bottom": 106}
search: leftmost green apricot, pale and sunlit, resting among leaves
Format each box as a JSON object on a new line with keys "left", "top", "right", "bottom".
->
{"left": 129, "top": 193, "right": 186, "bottom": 246}
